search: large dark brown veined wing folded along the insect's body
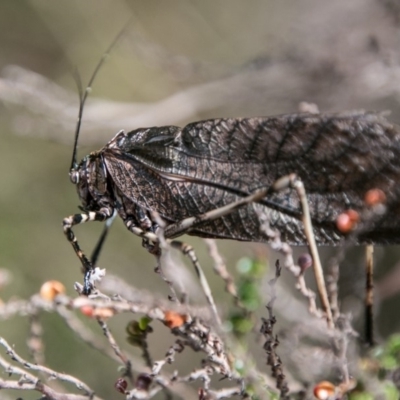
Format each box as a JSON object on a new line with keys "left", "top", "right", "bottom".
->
{"left": 104, "top": 113, "right": 400, "bottom": 244}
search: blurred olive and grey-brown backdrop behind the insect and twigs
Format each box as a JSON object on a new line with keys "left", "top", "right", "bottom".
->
{"left": 0, "top": 0, "right": 400, "bottom": 399}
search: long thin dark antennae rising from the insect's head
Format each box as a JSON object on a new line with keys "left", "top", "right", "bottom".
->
{"left": 70, "top": 18, "right": 132, "bottom": 171}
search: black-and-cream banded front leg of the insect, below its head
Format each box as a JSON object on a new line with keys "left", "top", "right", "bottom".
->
{"left": 63, "top": 208, "right": 114, "bottom": 295}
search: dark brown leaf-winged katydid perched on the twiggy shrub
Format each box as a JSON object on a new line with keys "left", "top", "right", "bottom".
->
{"left": 63, "top": 44, "right": 400, "bottom": 294}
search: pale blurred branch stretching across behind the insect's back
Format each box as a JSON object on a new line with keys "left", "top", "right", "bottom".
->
{"left": 0, "top": 31, "right": 400, "bottom": 144}
